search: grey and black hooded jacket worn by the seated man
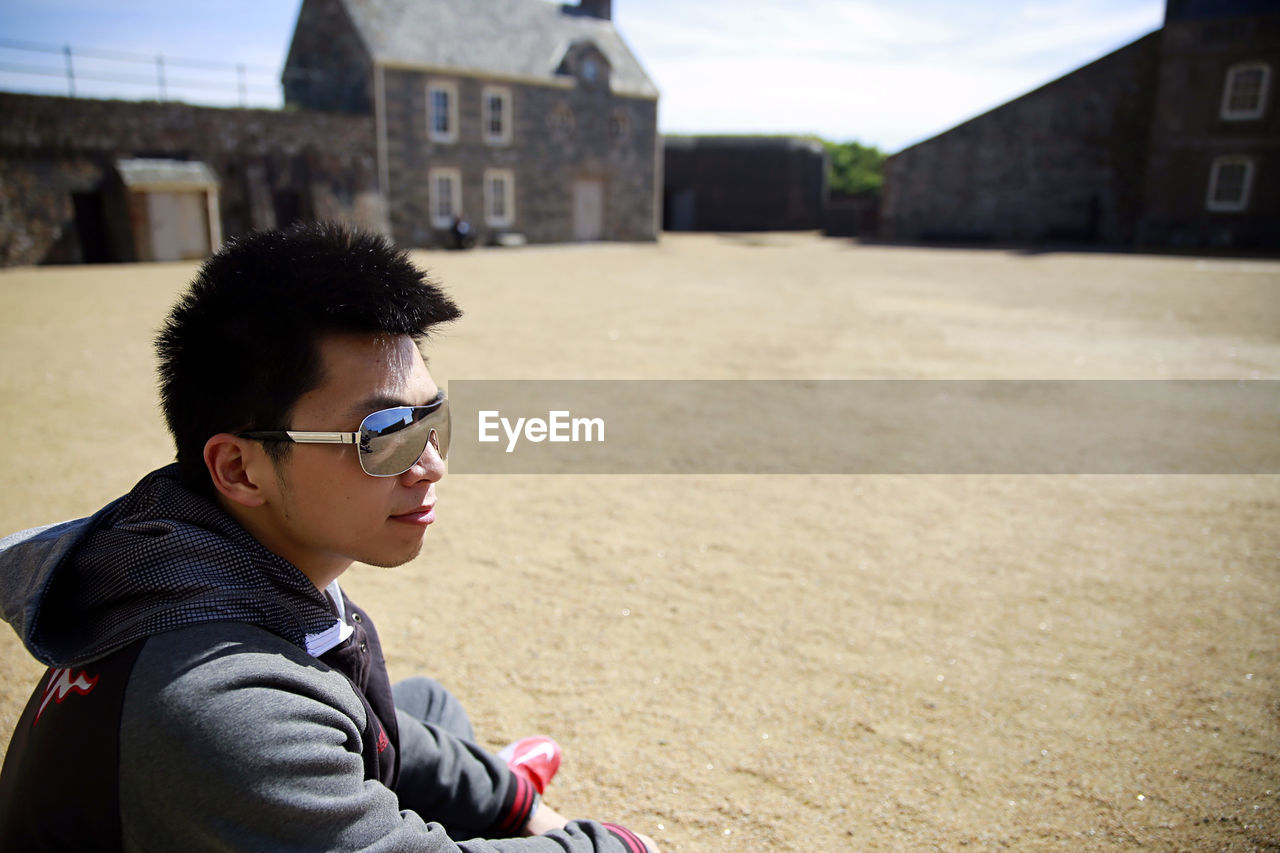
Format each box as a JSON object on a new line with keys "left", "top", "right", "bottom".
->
{"left": 0, "top": 466, "right": 645, "bottom": 853}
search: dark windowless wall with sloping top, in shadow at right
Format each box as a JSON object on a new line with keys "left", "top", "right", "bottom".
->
{"left": 881, "top": 33, "right": 1160, "bottom": 245}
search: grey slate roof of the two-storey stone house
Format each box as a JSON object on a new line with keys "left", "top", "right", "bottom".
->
{"left": 342, "top": 0, "right": 658, "bottom": 97}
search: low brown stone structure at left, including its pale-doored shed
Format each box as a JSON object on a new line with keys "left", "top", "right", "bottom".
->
{"left": 0, "top": 93, "right": 385, "bottom": 266}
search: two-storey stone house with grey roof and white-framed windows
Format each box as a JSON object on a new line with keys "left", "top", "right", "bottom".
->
{"left": 284, "top": 0, "right": 660, "bottom": 246}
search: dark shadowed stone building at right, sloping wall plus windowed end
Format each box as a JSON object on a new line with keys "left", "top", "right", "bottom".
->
{"left": 881, "top": 0, "right": 1280, "bottom": 250}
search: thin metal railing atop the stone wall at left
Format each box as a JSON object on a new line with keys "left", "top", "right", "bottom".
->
{"left": 0, "top": 38, "right": 307, "bottom": 108}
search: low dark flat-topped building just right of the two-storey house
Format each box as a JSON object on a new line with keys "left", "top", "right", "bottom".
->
{"left": 662, "top": 136, "right": 827, "bottom": 231}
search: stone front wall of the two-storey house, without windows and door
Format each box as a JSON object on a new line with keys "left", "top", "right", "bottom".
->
{"left": 383, "top": 69, "right": 658, "bottom": 246}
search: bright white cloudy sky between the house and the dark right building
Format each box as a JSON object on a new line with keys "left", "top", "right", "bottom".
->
{"left": 618, "top": 0, "right": 1164, "bottom": 150}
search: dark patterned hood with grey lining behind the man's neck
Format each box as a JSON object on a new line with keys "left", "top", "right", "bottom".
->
{"left": 0, "top": 465, "right": 342, "bottom": 666}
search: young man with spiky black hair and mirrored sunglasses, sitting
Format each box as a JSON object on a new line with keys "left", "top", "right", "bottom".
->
{"left": 0, "top": 225, "right": 655, "bottom": 853}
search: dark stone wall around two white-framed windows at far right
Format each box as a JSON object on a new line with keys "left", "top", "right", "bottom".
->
{"left": 1139, "top": 13, "right": 1280, "bottom": 248}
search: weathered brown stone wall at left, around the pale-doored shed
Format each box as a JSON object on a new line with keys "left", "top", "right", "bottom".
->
{"left": 0, "top": 93, "right": 376, "bottom": 266}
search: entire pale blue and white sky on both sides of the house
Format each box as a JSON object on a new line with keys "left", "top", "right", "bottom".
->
{"left": 0, "top": 0, "right": 1165, "bottom": 152}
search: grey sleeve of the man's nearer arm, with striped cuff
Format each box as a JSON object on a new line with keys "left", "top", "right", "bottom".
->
{"left": 120, "top": 624, "right": 643, "bottom": 853}
